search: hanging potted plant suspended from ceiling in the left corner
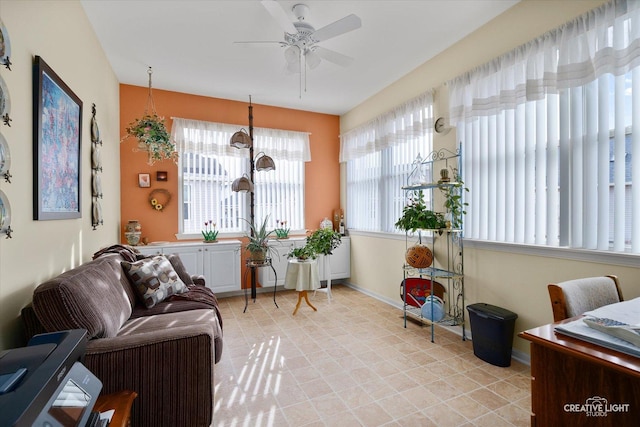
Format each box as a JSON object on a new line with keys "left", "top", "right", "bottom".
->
{"left": 122, "top": 67, "right": 178, "bottom": 165}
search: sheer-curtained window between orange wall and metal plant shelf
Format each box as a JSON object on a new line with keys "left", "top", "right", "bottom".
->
{"left": 340, "top": 93, "right": 433, "bottom": 233}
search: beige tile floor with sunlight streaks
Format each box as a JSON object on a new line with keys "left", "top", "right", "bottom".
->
{"left": 213, "top": 285, "right": 530, "bottom": 427}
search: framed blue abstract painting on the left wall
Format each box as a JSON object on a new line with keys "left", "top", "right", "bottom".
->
{"left": 33, "top": 56, "right": 82, "bottom": 220}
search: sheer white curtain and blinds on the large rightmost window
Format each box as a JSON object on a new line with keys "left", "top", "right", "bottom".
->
{"left": 449, "top": 0, "right": 640, "bottom": 253}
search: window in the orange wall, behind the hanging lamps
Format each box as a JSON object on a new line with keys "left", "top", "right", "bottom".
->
{"left": 172, "top": 118, "right": 311, "bottom": 235}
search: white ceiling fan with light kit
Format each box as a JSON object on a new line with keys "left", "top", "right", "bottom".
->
{"left": 240, "top": 0, "right": 362, "bottom": 73}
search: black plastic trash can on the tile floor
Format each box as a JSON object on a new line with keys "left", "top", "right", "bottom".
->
{"left": 467, "top": 303, "right": 518, "bottom": 367}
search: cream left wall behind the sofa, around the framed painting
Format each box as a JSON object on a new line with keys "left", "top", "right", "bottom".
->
{"left": 0, "top": 0, "right": 120, "bottom": 349}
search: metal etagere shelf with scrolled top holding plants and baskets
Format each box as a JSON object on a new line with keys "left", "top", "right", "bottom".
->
{"left": 402, "top": 149, "right": 466, "bottom": 342}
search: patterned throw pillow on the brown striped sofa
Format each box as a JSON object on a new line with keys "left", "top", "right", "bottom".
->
{"left": 122, "top": 255, "right": 189, "bottom": 308}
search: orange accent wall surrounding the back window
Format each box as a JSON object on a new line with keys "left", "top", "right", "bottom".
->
{"left": 120, "top": 85, "right": 340, "bottom": 243}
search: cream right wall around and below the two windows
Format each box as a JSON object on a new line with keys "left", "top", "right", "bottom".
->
{"left": 341, "top": 0, "right": 640, "bottom": 353}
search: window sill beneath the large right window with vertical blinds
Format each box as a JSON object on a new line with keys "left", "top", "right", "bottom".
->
{"left": 464, "top": 239, "right": 640, "bottom": 268}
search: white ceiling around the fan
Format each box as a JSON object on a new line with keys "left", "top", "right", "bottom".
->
{"left": 81, "top": 0, "right": 517, "bottom": 115}
